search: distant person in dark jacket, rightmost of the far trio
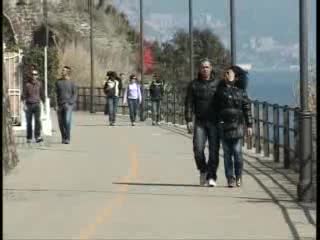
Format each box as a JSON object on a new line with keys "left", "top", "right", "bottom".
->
{"left": 149, "top": 74, "right": 164, "bottom": 125}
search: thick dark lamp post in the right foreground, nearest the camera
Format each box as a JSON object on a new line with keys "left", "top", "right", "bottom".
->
{"left": 297, "top": 0, "right": 313, "bottom": 202}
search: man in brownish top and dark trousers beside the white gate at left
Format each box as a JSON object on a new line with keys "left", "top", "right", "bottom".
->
{"left": 22, "top": 68, "right": 45, "bottom": 143}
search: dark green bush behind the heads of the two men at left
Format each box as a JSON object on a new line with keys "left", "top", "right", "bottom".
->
{"left": 23, "top": 47, "right": 59, "bottom": 102}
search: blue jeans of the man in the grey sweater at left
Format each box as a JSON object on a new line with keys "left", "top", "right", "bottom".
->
{"left": 57, "top": 104, "right": 73, "bottom": 141}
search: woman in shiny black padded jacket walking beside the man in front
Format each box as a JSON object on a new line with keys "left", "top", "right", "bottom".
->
{"left": 215, "top": 66, "right": 252, "bottom": 187}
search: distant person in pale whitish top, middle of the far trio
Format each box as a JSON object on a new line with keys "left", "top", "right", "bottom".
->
{"left": 123, "top": 74, "right": 142, "bottom": 126}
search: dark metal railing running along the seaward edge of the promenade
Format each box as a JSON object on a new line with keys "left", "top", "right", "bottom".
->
{"left": 76, "top": 87, "right": 316, "bottom": 172}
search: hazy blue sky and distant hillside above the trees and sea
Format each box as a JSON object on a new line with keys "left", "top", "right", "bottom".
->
{"left": 114, "top": 0, "right": 316, "bottom": 68}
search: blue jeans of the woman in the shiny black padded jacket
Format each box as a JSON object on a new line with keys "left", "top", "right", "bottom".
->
{"left": 222, "top": 138, "right": 243, "bottom": 179}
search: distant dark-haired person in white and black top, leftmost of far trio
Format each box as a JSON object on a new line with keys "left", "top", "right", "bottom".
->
{"left": 103, "top": 71, "right": 120, "bottom": 126}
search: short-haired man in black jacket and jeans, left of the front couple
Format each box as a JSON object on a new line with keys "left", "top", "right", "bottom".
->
{"left": 185, "top": 59, "right": 220, "bottom": 187}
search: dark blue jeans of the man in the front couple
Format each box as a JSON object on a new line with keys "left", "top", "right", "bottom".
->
{"left": 193, "top": 120, "right": 220, "bottom": 180}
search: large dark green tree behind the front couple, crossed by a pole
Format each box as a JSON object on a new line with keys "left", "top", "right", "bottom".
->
{"left": 152, "top": 29, "right": 231, "bottom": 88}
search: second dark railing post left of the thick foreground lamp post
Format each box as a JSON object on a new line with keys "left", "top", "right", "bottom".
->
{"left": 283, "top": 105, "right": 290, "bottom": 169}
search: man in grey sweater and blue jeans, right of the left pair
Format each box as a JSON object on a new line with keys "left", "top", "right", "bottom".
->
{"left": 56, "top": 66, "right": 77, "bottom": 144}
